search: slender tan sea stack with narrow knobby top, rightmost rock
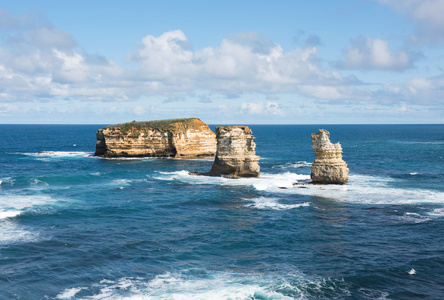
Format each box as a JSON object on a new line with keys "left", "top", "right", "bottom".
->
{"left": 311, "top": 129, "right": 348, "bottom": 184}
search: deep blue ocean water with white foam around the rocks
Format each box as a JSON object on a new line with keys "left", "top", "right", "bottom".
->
{"left": 0, "top": 125, "right": 444, "bottom": 299}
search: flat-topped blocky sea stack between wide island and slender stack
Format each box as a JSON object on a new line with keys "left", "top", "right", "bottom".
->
{"left": 208, "top": 126, "right": 260, "bottom": 178}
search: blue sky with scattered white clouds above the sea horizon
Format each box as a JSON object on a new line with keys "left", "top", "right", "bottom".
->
{"left": 0, "top": 0, "right": 444, "bottom": 124}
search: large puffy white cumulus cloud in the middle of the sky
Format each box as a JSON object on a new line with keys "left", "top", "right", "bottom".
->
{"left": 124, "top": 30, "right": 346, "bottom": 94}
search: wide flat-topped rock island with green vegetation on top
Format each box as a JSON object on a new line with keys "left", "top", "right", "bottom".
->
{"left": 95, "top": 118, "right": 216, "bottom": 158}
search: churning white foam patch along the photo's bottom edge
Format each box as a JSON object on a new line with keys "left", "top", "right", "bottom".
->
{"left": 60, "top": 270, "right": 358, "bottom": 300}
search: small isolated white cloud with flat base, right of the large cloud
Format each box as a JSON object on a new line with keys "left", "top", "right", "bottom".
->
{"left": 339, "top": 36, "right": 412, "bottom": 70}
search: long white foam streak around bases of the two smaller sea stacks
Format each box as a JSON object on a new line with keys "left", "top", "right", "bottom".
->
{"left": 154, "top": 170, "right": 444, "bottom": 204}
